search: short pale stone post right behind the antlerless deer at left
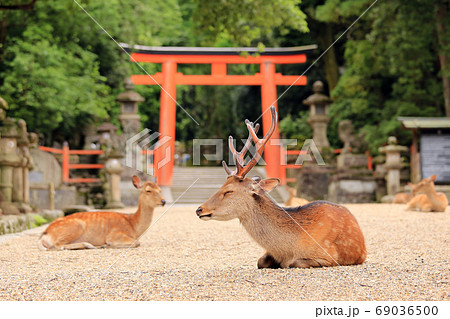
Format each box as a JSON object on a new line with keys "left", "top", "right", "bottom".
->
{"left": 105, "top": 152, "right": 125, "bottom": 209}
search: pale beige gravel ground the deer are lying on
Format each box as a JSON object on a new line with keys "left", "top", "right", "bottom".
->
{"left": 0, "top": 204, "right": 450, "bottom": 300}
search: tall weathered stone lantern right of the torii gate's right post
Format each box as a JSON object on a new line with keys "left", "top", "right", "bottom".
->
{"left": 303, "top": 81, "right": 332, "bottom": 150}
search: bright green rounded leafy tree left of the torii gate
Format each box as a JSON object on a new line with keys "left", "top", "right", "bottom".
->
{"left": 0, "top": 24, "right": 111, "bottom": 142}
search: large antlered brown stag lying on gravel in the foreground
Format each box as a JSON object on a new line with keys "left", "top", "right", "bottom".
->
{"left": 196, "top": 106, "right": 367, "bottom": 268}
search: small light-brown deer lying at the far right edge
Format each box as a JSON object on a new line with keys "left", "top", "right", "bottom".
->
{"left": 406, "top": 174, "right": 448, "bottom": 212}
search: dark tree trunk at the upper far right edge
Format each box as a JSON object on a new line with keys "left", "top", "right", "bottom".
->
{"left": 436, "top": 1, "right": 450, "bottom": 117}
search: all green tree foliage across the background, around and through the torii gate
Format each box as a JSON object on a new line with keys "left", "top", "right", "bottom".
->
{"left": 0, "top": 0, "right": 450, "bottom": 156}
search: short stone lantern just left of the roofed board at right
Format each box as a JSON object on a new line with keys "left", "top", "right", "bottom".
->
{"left": 378, "top": 136, "right": 408, "bottom": 202}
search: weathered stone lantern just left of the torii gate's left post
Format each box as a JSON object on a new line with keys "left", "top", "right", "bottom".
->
{"left": 116, "top": 78, "right": 145, "bottom": 138}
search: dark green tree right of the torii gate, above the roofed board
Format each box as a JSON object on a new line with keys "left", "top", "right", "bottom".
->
{"left": 317, "top": 0, "right": 449, "bottom": 152}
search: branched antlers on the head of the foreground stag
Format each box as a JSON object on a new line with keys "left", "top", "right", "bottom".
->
{"left": 222, "top": 105, "right": 277, "bottom": 177}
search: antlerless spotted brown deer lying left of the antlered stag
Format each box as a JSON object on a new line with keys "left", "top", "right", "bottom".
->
{"left": 38, "top": 176, "right": 166, "bottom": 250}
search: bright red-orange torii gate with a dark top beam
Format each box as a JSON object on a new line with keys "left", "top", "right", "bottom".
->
{"left": 121, "top": 43, "right": 317, "bottom": 186}
